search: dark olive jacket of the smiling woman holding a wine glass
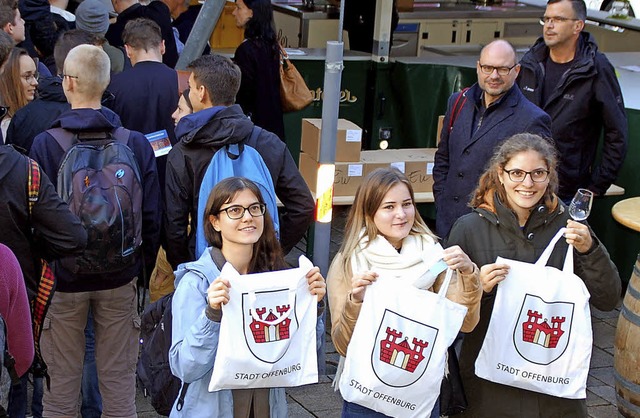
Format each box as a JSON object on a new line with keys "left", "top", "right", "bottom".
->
{"left": 446, "top": 192, "right": 621, "bottom": 418}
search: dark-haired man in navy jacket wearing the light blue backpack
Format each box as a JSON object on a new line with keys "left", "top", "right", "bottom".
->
{"left": 165, "top": 55, "right": 314, "bottom": 268}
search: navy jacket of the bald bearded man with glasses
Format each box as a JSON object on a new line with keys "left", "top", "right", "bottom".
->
{"left": 433, "top": 83, "right": 551, "bottom": 237}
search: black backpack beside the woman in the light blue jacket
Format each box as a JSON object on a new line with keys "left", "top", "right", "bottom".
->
{"left": 136, "top": 292, "right": 189, "bottom": 415}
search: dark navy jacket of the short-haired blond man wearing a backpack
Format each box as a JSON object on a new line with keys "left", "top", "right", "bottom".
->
{"left": 31, "top": 107, "right": 161, "bottom": 292}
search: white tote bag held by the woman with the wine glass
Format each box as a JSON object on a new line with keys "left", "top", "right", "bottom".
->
{"left": 475, "top": 228, "right": 593, "bottom": 399}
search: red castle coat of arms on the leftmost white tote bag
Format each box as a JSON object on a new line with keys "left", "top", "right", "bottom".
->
{"left": 242, "top": 289, "right": 299, "bottom": 363}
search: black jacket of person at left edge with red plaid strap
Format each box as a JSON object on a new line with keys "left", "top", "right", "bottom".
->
{"left": 0, "top": 145, "right": 87, "bottom": 300}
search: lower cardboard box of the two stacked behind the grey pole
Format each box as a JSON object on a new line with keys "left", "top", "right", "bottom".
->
{"left": 299, "top": 152, "right": 365, "bottom": 196}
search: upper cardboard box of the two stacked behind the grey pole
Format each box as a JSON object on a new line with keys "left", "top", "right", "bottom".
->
{"left": 300, "top": 119, "right": 362, "bottom": 162}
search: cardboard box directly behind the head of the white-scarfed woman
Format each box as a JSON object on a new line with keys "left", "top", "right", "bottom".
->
{"left": 360, "top": 148, "right": 436, "bottom": 193}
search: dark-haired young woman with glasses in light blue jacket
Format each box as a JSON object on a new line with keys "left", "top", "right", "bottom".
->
{"left": 169, "top": 177, "right": 326, "bottom": 418}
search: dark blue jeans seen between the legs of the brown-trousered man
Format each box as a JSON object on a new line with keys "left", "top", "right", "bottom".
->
{"left": 80, "top": 308, "right": 102, "bottom": 418}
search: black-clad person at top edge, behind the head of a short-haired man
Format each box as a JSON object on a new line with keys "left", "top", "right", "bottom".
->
{"left": 105, "top": 0, "right": 178, "bottom": 68}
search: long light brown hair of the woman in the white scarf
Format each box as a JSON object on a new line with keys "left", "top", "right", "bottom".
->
{"left": 339, "top": 167, "right": 437, "bottom": 276}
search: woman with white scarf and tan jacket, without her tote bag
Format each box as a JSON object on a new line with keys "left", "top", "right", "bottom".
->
{"left": 327, "top": 168, "right": 482, "bottom": 417}
